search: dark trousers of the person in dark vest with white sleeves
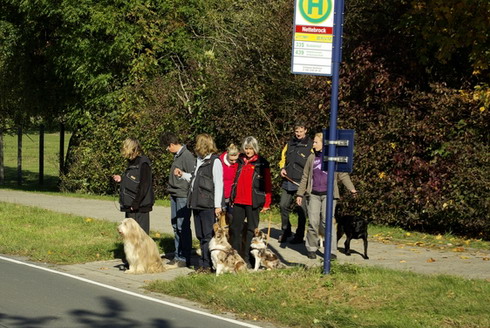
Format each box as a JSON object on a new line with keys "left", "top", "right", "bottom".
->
{"left": 192, "top": 208, "right": 216, "bottom": 268}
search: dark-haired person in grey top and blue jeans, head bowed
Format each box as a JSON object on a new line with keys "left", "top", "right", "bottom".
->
{"left": 160, "top": 132, "right": 196, "bottom": 267}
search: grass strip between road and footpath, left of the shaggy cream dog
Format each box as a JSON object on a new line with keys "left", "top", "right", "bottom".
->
{"left": 0, "top": 203, "right": 174, "bottom": 264}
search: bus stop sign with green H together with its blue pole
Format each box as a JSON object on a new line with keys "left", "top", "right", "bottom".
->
{"left": 291, "top": 0, "right": 346, "bottom": 274}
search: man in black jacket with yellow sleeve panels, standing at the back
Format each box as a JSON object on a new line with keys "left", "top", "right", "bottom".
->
{"left": 279, "top": 122, "right": 313, "bottom": 244}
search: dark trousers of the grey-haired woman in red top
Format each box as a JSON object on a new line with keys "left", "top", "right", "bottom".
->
{"left": 230, "top": 204, "right": 260, "bottom": 263}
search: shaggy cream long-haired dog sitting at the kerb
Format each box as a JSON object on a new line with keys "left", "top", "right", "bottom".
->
{"left": 117, "top": 218, "right": 166, "bottom": 274}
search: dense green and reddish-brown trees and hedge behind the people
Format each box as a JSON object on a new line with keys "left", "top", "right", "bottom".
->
{"left": 0, "top": 0, "right": 490, "bottom": 239}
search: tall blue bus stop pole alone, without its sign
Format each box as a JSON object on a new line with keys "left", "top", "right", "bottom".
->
{"left": 323, "top": 0, "right": 344, "bottom": 274}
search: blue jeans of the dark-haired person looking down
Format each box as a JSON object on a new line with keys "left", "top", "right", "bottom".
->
{"left": 170, "top": 196, "right": 192, "bottom": 265}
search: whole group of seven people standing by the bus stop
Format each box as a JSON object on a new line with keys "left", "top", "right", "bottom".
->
{"left": 113, "top": 123, "right": 356, "bottom": 272}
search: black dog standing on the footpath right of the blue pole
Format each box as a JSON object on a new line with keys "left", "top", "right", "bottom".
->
{"left": 337, "top": 215, "right": 369, "bottom": 260}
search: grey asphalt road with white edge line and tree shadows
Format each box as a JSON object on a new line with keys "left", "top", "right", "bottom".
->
{"left": 0, "top": 257, "right": 264, "bottom": 328}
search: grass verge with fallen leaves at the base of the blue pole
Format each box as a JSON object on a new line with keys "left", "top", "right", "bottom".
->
{"left": 147, "top": 263, "right": 490, "bottom": 328}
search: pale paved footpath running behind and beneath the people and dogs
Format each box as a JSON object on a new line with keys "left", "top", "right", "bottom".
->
{"left": 0, "top": 189, "right": 490, "bottom": 282}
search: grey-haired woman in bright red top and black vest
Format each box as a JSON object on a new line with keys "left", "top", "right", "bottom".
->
{"left": 230, "top": 137, "right": 272, "bottom": 267}
